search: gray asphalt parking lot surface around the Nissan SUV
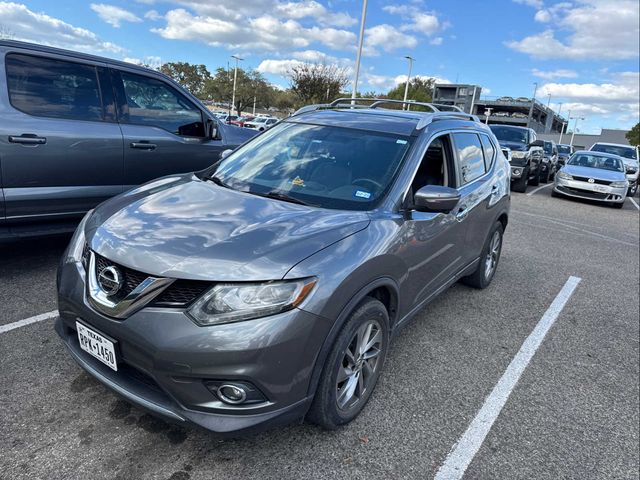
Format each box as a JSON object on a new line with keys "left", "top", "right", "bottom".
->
{"left": 0, "top": 187, "right": 640, "bottom": 480}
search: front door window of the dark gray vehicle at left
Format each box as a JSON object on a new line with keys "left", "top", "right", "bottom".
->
{"left": 120, "top": 72, "right": 204, "bottom": 137}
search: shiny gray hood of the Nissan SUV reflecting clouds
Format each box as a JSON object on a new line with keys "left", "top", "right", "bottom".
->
{"left": 85, "top": 174, "right": 369, "bottom": 281}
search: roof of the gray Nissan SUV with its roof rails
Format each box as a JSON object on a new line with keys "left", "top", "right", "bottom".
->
{"left": 285, "top": 108, "right": 484, "bottom": 136}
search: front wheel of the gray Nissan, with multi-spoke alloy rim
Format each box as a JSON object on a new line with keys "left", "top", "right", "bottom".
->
{"left": 307, "top": 297, "right": 389, "bottom": 430}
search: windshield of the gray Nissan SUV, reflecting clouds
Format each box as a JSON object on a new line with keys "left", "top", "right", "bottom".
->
{"left": 208, "top": 123, "right": 411, "bottom": 210}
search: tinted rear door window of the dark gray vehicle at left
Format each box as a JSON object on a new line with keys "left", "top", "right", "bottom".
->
{"left": 5, "top": 53, "right": 103, "bottom": 121}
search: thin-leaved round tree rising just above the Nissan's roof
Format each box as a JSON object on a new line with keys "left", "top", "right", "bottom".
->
{"left": 288, "top": 63, "right": 349, "bottom": 106}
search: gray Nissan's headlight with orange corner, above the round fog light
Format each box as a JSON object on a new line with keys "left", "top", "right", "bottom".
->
{"left": 188, "top": 278, "right": 317, "bottom": 326}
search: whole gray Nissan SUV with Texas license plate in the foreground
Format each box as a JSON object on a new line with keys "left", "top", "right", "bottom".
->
{"left": 55, "top": 99, "right": 510, "bottom": 434}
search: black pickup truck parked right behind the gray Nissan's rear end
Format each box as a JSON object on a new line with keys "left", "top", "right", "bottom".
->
{"left": 491, "top": 125, "right": 543, "bottom": 193}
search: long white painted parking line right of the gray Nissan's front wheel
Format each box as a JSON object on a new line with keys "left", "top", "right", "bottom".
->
{"left": 435, "top": 277, "right": 581, "bottom": 480}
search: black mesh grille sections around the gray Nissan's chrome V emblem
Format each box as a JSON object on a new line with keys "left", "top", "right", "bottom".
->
{"left": 94, "top": 252, "right": 211, "bottom": 307}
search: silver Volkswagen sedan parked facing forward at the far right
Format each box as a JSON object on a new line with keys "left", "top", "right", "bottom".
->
{"left": 552, "top": 150, "right": 629, "bottom": 208}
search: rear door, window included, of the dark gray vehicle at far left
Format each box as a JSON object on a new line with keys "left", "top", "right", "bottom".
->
{"left": 0, "top": 54, "right": 123, "bottom": 219}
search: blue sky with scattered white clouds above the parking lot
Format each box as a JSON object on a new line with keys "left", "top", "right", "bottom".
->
{"left": 0, "top": 0, "right": 640, "bottom": 132}
